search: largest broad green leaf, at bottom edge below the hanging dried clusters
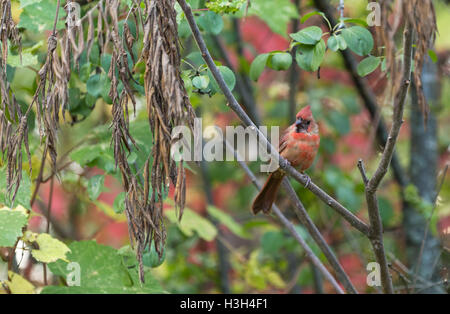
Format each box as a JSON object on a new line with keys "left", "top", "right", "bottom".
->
{"left": 42, "top": 241, "right": 163, "bottom": 294}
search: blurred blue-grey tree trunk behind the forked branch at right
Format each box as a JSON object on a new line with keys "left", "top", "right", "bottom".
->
{"left": 403, "top": 60, "right": 444, "bottom": 293}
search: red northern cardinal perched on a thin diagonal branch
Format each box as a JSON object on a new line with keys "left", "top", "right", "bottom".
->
{"left": 252, "top": 106, "right": 320, "bottom": 215}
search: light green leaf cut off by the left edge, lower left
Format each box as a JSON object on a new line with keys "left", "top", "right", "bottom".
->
{"left": 0, "top": 209, "right": 28, "bottom": 247}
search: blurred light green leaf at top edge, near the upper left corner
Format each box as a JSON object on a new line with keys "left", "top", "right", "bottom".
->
{"left": 18, "top": 0, "right": 66, "bottom": 33}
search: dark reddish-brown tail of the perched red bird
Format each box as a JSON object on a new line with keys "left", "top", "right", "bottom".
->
{"left": 252, "top": 169, "right": 285, "bottom": 215}
